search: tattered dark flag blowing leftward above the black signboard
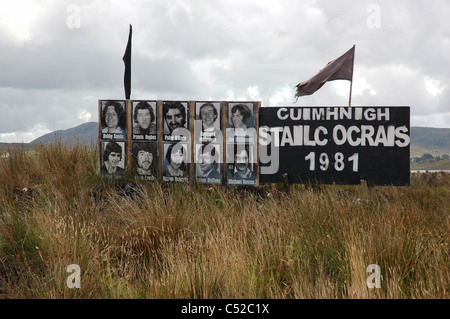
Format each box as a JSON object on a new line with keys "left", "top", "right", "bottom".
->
{"left": 295, "top": 46, "right": 355, "bottom": 97}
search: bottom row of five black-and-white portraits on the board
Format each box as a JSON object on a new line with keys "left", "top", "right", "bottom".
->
{"left": 101, "top": 141, "right": 255, "bottom": 185}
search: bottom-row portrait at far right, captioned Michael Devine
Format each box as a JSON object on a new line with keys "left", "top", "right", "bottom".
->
{"left": 227, "top": 143, "right": 256, "bottom": 185}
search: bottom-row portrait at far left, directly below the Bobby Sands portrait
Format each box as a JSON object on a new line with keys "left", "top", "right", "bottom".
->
{"left": 100, "top": 141, "right": 126, "bottom": 176}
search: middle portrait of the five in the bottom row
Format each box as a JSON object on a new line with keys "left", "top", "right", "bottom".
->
{"left": 162, "top": 142, "right": 190, "bottom": 182}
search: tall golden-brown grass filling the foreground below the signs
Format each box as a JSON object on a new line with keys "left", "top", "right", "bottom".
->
{"left": 0, "top": 143, "right": 450, "bottom": 298}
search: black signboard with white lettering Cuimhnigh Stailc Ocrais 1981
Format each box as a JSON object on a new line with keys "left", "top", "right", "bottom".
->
{"left": 259, "top": 106, "right": 410, "bottom": 186}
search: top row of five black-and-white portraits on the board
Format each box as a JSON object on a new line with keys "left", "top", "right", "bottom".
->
{"left": 100, "top": 100, "right": 255, "bottom": 142}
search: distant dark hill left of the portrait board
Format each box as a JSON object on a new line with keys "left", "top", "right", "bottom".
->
{"left": 30, "top": 122, "right": 98, "bottom": 145}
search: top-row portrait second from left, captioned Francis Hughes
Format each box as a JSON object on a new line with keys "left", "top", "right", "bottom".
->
{"left": 132, "top": 101, "right": 158, "bottom": 141}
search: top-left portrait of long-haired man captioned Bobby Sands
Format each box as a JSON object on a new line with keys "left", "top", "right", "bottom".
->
{"left": 100, "top": 100, "right": 127, "bottom": 140}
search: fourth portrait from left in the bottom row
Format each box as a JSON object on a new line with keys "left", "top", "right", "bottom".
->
{"left": 195, "top": 143, "right": 222, "bottom": 184}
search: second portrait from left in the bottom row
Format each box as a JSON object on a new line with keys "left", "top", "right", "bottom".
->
{"left": 132, "top": 142, "right": 158, "bottom": 180}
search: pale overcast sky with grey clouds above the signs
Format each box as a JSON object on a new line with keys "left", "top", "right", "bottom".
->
{"left": 0, "top": 0, "right": 450, "bottom": 142}
